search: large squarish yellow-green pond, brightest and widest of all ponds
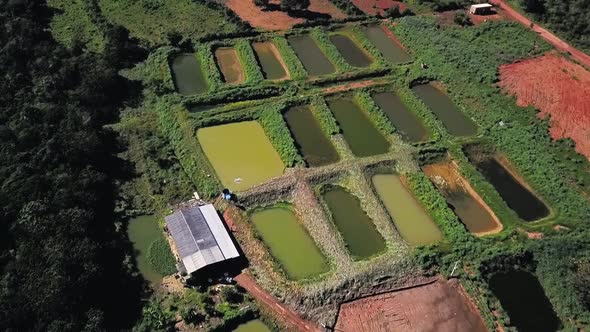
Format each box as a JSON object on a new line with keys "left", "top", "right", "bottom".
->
{"left": 197, "top": 121, "right": 285, "bottom": 191}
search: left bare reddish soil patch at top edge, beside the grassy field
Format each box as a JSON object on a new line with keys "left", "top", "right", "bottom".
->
{"left": 223, "top": 0, "right": 305, "bottom": 30}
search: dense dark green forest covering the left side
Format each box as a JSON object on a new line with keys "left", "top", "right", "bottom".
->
{"left": 0, "top": 0, "right": 143, "bottom": 331}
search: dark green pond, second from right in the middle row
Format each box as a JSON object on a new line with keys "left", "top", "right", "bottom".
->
{"left": 372, "top": 92, "right": 428, "bottom": 142}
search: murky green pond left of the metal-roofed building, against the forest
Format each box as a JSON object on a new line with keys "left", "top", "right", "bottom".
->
{"left": 127, "top": 215, "right": 163, "bottom": 284}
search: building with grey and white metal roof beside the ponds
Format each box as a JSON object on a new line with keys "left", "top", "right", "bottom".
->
{"left": 166, "top": 204, "right": 240, "bottom": 274}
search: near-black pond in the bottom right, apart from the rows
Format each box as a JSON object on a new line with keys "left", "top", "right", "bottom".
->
{"left": 489, "top": 270, "right": 561, "bottom": 332}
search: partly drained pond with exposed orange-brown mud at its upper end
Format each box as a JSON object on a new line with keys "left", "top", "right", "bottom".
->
{"left": 422, "top": 162, "right": 502, "bottom": 235}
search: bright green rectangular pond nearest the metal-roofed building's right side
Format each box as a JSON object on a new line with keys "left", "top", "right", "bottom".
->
{"left": 251, "top": 207, "right": 329, "bottom": 280}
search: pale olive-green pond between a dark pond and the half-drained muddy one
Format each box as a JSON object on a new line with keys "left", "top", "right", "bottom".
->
{"left": 371, "top": 174, "right": 442, "bottom": 246}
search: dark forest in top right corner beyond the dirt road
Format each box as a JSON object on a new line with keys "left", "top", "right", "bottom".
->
{"left": 519, "top": 0, "right": 590, "bottom": 52}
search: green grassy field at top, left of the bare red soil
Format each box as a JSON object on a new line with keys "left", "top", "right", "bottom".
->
{"left": 99, "top": 0, "right": 236, "bottom": 45}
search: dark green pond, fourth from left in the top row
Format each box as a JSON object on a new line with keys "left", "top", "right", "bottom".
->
{"left": 288, "top": 35, "right": 336, "bottom": 76}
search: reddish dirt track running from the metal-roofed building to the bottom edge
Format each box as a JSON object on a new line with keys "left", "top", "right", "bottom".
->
{"left": 235, "top": 273, "right": 322, "bottom": 332}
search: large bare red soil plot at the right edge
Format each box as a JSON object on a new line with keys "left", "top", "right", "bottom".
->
{"left": 499, "top": 54, "right": 590, "bottom": 160}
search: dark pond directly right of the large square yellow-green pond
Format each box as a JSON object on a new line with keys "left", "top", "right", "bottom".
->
{"left": 285, "top": 106, "right": 339, "bottom": 166}
